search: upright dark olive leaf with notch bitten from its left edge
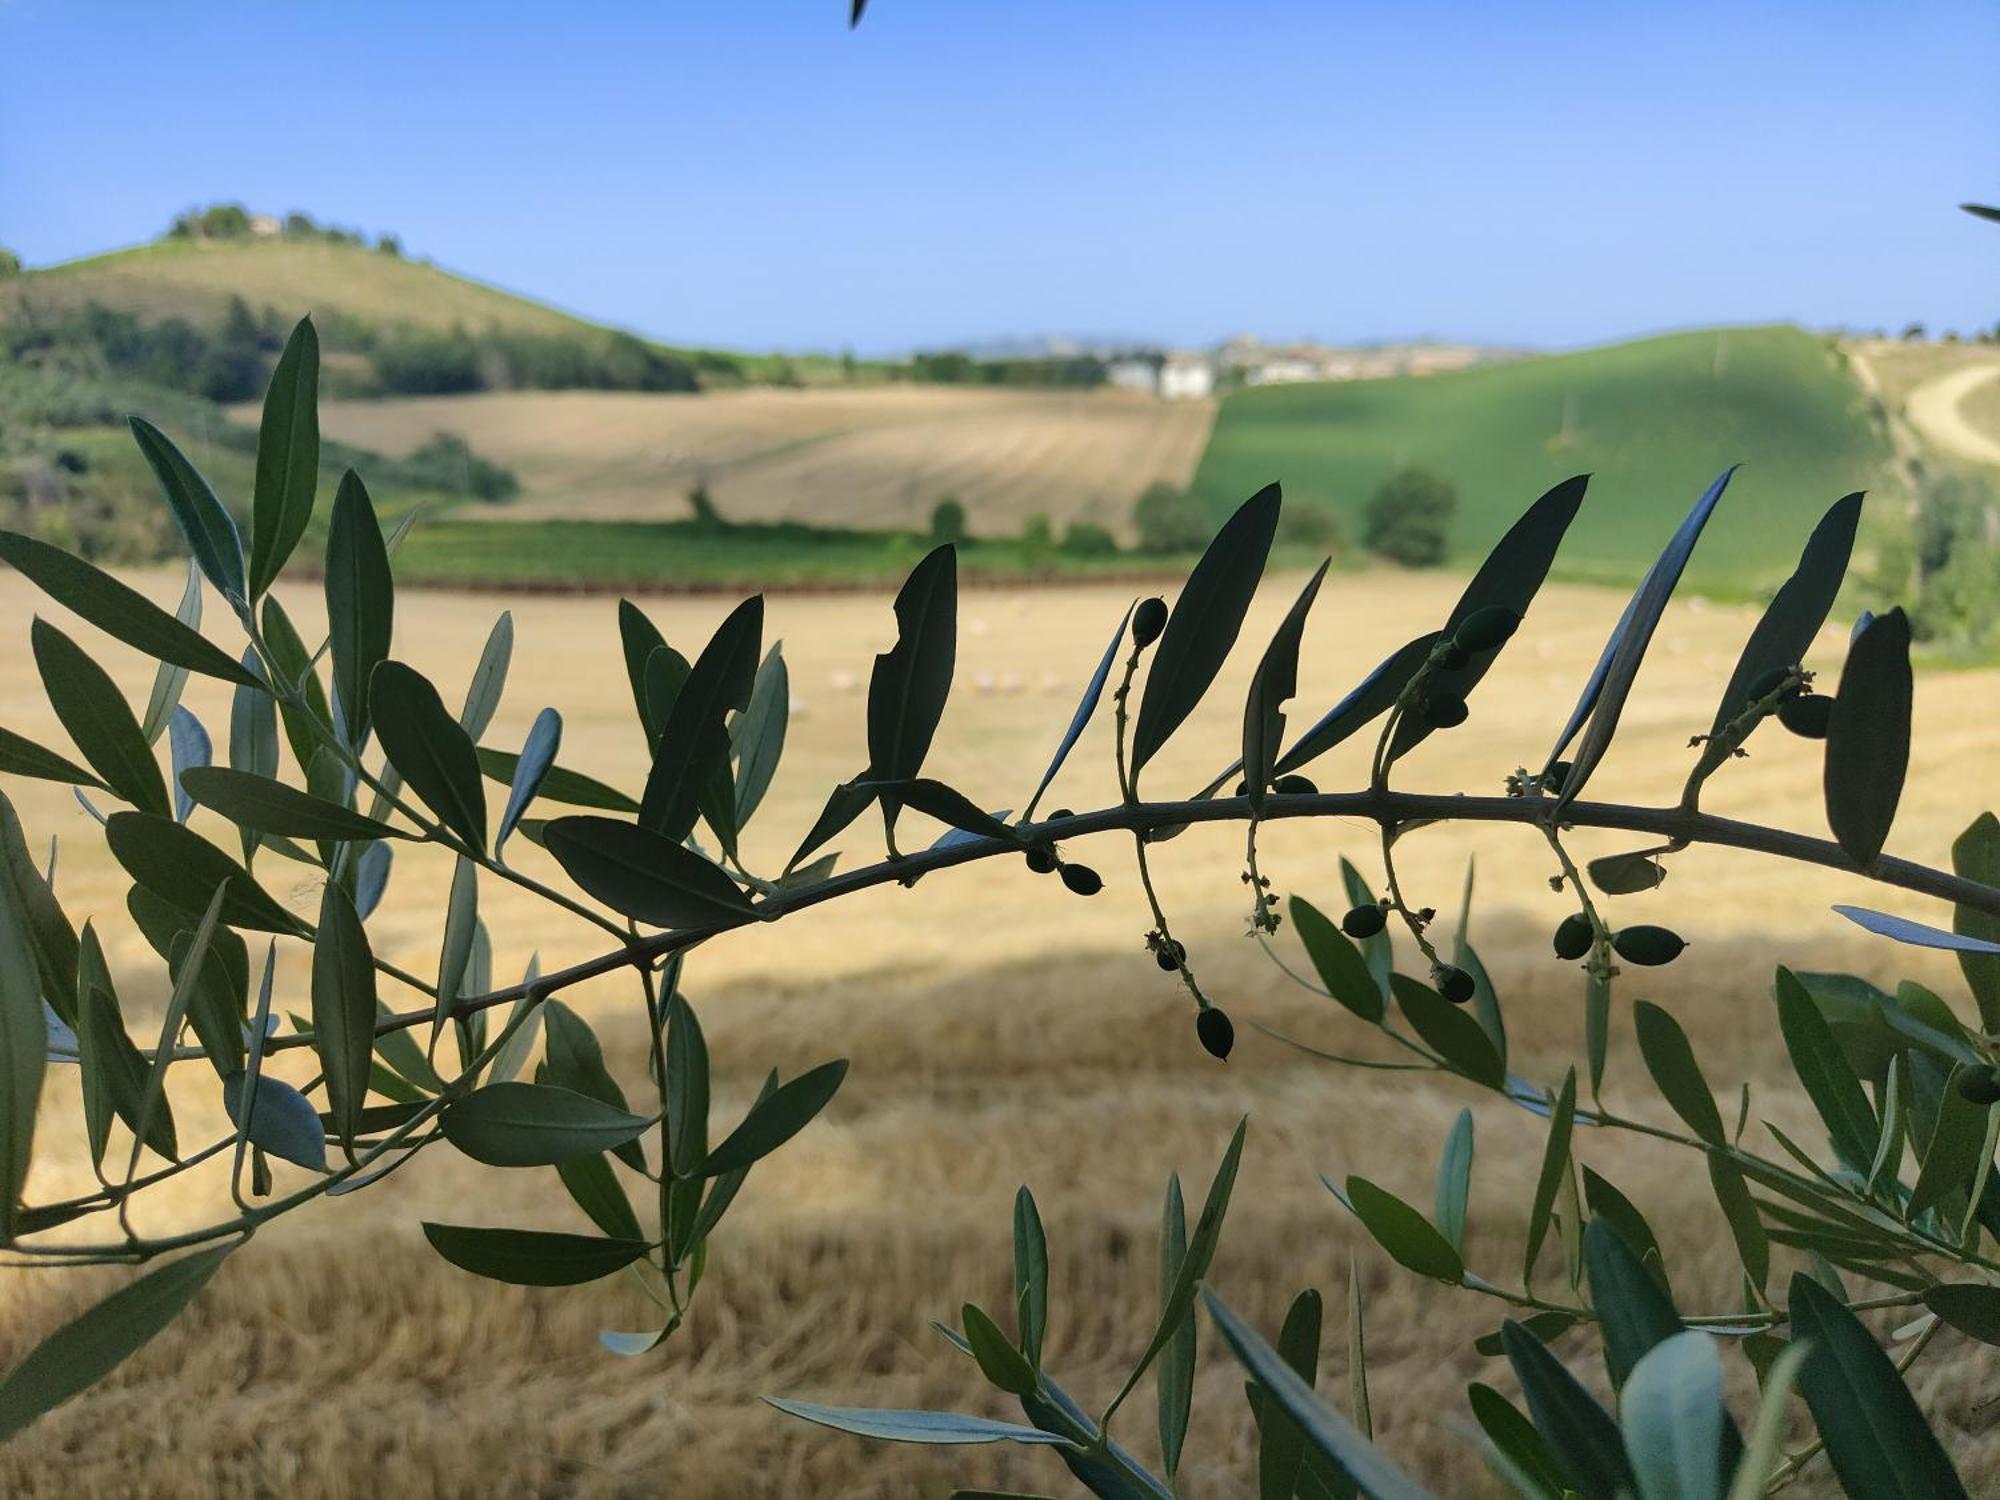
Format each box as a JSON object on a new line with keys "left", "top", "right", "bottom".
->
{"left": 868, "top": 544, "right": 958, "bottom": 828}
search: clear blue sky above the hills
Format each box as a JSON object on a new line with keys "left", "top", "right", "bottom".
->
{"left": 0, "top": 0, "right": 2000, "bottom": 352}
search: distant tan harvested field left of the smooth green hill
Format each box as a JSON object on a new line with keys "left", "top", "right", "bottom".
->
{"left": 296, "top": 386, "right": 1214, "bottom": 536}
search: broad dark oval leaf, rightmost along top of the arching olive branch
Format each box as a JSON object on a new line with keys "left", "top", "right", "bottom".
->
{"left": 1806, "top": 610, "right": 1912, "bottom": 868}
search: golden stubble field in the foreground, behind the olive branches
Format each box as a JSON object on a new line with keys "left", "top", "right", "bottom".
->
{"left": 0, "top": 572, "right": 2000, "bottom": 1500}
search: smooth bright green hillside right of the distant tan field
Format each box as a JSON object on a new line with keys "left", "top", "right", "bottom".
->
{"left": 1194, "top": 326, "right": 1888, "bottom": 592}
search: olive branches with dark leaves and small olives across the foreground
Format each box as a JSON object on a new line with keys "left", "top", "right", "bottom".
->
{"left": 0, "top": 324, "right": 2000, "bottom": 1500}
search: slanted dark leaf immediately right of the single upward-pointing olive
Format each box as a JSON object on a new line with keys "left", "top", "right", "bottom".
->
{"left": 1132, "top": 484, "right": 1280, "bottom": 780}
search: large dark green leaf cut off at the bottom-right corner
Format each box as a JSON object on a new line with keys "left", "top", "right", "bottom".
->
{"left": 1790, "top": 1272, "right": 1968, "bottom": 1500}
